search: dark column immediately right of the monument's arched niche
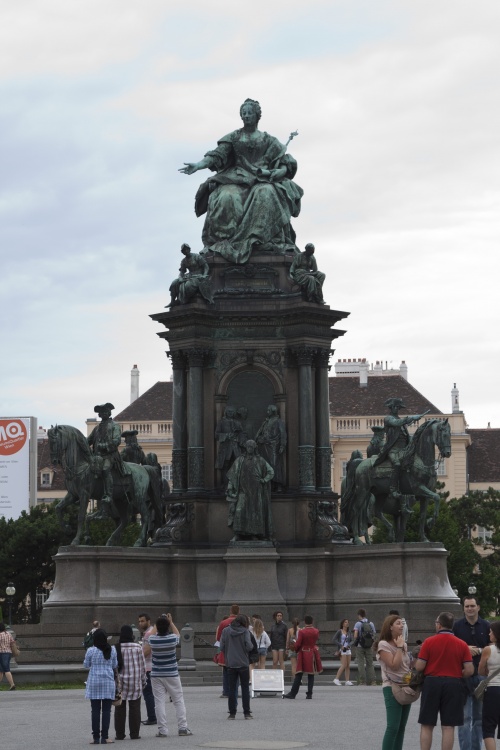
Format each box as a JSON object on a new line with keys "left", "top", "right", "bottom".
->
{"left": 294, "top": 346, "right": 316, "bottom": 492}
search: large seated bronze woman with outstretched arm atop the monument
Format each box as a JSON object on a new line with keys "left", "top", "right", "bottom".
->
{"left": 179, "top": 99, "right": 303, "bottom": 263}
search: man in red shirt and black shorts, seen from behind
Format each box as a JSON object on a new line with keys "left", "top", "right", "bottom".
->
{"left": 415, "top": 612, "right": 474, "bottom": 750}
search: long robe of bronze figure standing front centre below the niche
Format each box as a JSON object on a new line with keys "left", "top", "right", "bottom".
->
{"left": 227, "top": 454, "right": 274, "bottom": 539}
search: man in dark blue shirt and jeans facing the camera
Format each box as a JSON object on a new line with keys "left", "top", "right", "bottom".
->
{"left": 453, "top": 596, "right": 490, "bottom": 750}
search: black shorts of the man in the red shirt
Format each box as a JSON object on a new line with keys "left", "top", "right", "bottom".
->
{"left": 418, "top": 675, "right": 464, "bottom": 727}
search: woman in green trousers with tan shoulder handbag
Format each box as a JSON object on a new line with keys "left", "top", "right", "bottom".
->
{"left": 376, "top": 615, "right": 412, "bottom": 750}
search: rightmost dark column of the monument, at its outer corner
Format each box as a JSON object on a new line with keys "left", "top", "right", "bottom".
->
{"left": 316, "top": 349, "right": 332, "bottom": 492}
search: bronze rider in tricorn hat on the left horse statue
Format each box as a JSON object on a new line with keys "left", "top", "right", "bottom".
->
{"left": 87, "top": 402, "right": 127, "bottom": 518}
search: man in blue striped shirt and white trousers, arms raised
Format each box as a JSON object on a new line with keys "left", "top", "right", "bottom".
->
{"left": 149, "top": 614, "right": 192, "bottom": 737}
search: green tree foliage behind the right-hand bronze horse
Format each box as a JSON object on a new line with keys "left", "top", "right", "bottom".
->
{"left": 372, "top": 485, "right": 500, "bottom": 617}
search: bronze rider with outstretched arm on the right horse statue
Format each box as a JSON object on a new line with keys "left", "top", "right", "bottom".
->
{"left": 374, "top": 398, "right": 428, "bottom": 515}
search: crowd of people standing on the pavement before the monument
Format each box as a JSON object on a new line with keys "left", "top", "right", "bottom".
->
{"left": 5, "top": 595, "right": 492, "bottom": 750}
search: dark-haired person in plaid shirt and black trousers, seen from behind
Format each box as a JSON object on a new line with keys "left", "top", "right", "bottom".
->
{"left": 115, "top": 625, "right": 147, "bottom": 740}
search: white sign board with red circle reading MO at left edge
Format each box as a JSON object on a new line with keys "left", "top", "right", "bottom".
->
{"left": 0, "top": 417, "right": 30, "bottom": 519}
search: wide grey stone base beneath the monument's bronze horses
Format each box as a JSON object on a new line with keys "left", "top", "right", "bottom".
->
{"left": 42, "top": 542, "right": 459, "bottom": 639}
